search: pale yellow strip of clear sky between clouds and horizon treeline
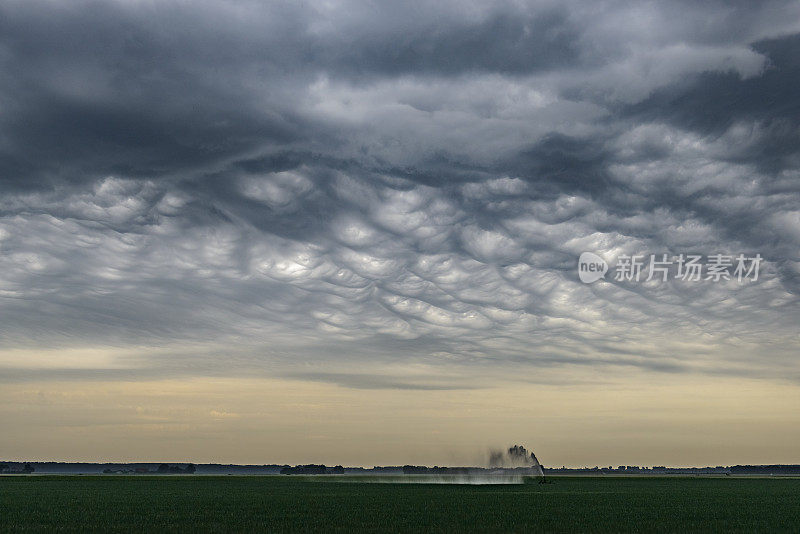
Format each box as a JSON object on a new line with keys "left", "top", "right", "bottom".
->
{"left": 0, "top": 371, "right": 800, "bottom": 466}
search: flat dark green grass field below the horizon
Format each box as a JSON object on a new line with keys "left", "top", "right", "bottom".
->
{"left": 0, "top": 476, "right": 800, "bottom": 532}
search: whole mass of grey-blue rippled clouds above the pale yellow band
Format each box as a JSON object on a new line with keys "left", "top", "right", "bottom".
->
{"left": 0, "top": 2, "right": 800, "bottom": 389}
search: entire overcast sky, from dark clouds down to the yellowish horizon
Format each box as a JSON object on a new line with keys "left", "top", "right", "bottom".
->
{"left": 0, "top": 0, "right": 800, "bottom": 465}
